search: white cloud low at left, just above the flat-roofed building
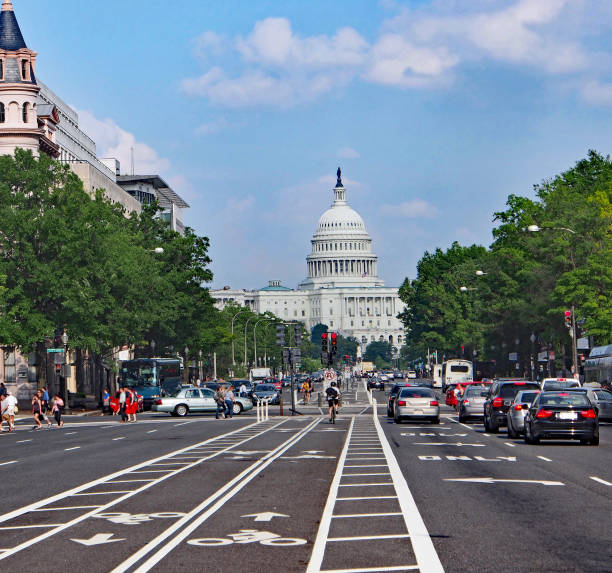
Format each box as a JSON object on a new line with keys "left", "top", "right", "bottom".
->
{"left": 77, "top": 110, "right": 170, "bottom": 174}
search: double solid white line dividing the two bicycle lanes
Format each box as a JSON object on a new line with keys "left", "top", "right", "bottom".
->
{"left": 112, "top": 418, "right": 321, "bottom": 573}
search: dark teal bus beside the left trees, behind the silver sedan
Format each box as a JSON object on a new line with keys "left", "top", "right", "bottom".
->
{"left": 119, "top": 358, "right": 181, "bottom": 409}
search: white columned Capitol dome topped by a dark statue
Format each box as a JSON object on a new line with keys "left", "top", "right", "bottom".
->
{"left": 300, "top": 168, "right": 384, "bottom": 289}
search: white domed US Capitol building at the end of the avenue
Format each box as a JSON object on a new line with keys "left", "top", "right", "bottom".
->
{"left": 211, "top": 168, "right": 404, "bottom": 349}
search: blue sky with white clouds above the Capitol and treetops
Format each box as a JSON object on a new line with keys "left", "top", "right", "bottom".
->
{"left": 13, "top": 0, "right": 612, "bottom": 288}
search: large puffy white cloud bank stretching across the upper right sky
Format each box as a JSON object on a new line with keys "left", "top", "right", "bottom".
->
{"left": 182, "top": 0, "right": 595, "bottom": 107}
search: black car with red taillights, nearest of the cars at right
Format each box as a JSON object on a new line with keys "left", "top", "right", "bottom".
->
{"left": 525, "top": 391, "right": 599, "bottom": 446}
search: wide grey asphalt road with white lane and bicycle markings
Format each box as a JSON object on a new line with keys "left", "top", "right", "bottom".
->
{"left": 0, "top": 382, "right": 612, "bottom": 573}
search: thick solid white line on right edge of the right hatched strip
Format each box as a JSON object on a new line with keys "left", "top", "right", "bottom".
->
{"left": 374, "top": 408, "right": 444, "bottom": 573}
